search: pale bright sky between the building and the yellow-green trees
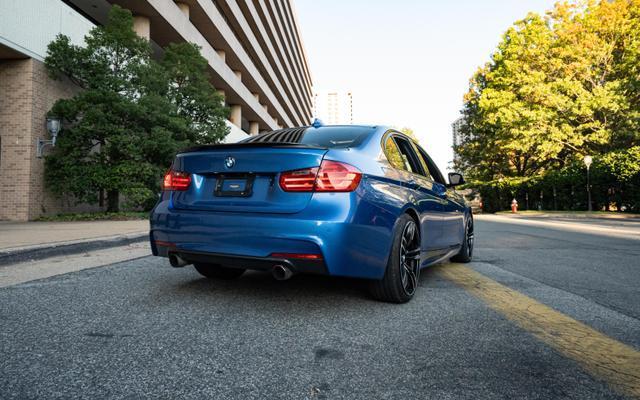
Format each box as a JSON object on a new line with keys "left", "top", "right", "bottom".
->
{"left": 292, "top": 0, "right": 554, "bottom": 171}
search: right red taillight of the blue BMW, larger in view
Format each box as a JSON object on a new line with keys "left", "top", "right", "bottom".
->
{"left": 280, "top": 160, "right": 362, "bottom": 192}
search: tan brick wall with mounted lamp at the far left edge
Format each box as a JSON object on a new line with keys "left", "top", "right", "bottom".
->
{"left": 0, "top": 59, "right": 100, "bottom": 221}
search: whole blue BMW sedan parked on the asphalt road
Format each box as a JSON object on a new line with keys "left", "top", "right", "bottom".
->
{"left": 150, "top": 124, "right": 474, "bottom": 303}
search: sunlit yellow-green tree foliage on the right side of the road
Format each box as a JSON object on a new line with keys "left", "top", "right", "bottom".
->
{"left": 456, "top": 0, "right": 640, "bottom": 208}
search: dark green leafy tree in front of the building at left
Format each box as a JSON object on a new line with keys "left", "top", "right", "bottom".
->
{"left": 45, "top": 6, "right": 228, "bottom": 211}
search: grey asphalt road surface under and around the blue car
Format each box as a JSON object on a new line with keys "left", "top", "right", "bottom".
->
{"left": 0, "top": 217, "right": 640, "bottom": 399}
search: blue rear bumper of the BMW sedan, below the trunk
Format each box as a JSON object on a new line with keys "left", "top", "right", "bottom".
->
{"left": 150, "top": 193, "right": 394, "bottom": 279}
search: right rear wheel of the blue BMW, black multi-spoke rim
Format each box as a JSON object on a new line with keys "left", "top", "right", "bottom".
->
{"left": 369, "top": 214, "right": 420, "bottom": 303}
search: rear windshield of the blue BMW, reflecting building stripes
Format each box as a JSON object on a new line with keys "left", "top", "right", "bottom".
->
{"left": 240, "top": 126, "right": 372, "bottom": 149}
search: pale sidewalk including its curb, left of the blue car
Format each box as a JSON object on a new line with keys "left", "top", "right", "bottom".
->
{"left": 0, "top": 220, "right": 149, "bottom": 265}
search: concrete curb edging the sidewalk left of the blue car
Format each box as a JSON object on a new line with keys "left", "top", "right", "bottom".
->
{"left": 0, "top": 232, "right": 149, "bottom": 267}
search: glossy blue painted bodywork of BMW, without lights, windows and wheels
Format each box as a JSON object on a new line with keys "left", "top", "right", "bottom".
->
{"left": 150, "top": 125, "right": 470, "bottom": 279}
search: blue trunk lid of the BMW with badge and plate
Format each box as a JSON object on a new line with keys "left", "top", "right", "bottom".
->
{"left": 172, "top": 143, "right": 327, "bottom": 213}
